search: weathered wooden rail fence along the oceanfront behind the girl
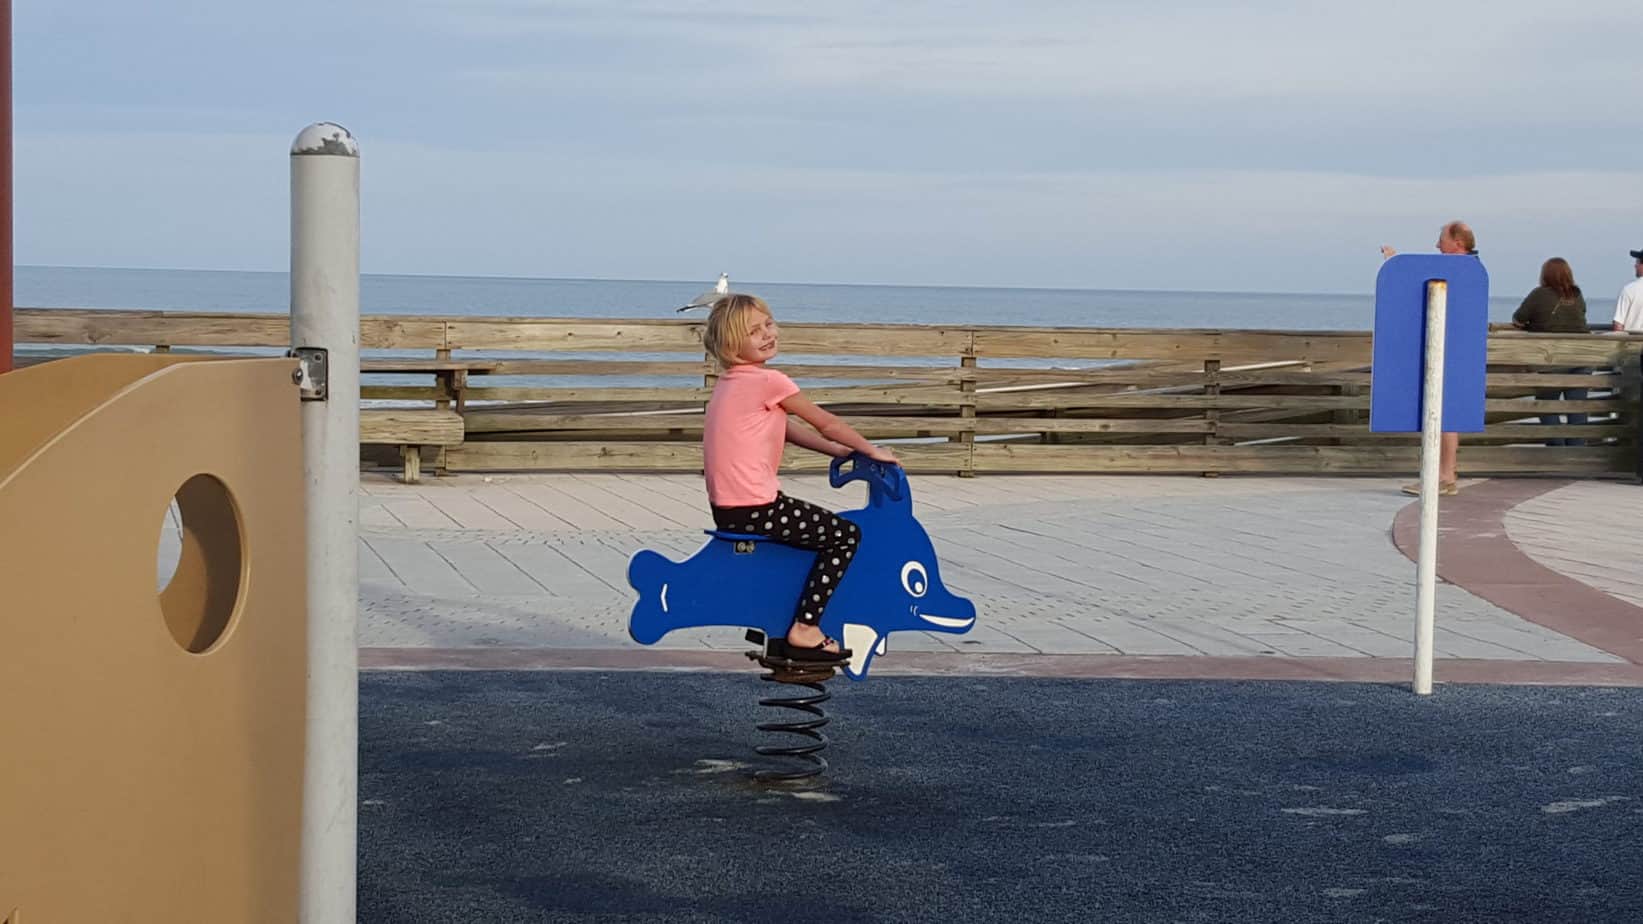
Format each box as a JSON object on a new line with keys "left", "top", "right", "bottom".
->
{"left": 16, "top": 309, "right": 1643, "bottom": 475}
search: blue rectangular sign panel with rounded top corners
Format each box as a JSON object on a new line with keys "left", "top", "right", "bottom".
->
{"left": 1369, "top": 253, "right": 1489, "bottom": 432}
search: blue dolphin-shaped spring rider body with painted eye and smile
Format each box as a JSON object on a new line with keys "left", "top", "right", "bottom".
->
{"left": 628, "top": 454, "right": 976, "bottom": 681}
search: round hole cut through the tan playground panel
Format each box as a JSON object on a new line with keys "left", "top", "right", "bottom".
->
{"left": 158, "top": 475, "right": 243, "bottom": 654}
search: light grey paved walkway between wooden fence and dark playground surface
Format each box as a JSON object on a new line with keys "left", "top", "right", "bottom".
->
{"left": 246, "top": 475, "right": 1643, "bottom": 682}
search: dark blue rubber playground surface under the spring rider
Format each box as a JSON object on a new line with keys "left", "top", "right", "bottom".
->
{"left": 360, "top": 668, "right": 1643, "bottom": 924}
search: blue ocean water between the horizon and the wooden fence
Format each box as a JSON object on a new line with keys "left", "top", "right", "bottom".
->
{"left": 15, "top": 266, "right": 1523, "bottom": 330}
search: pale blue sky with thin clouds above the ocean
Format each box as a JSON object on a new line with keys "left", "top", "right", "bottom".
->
{"left": 13, "top": 0, "right": 1643, "bottom": 294}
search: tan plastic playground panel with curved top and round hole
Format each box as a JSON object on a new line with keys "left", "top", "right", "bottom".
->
{"left": 0, "top": 355, "right": 306, "bottom": 924}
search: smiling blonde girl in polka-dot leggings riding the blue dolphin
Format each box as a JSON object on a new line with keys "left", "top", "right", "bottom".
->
{"left": 702, "top": 294, "right": 895, "bottom": 661}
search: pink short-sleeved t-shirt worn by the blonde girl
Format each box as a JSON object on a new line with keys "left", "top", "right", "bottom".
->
{"left": 702, "top": 363, "right": 798, "bottom": 506}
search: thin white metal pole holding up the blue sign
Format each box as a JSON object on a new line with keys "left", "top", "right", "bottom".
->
{"left": 1415, "top": 280, "right": 1449, "bottom": 695}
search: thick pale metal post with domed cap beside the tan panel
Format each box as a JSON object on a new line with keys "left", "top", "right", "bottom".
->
{"left": 291, "top": 122, "right": 360, "bottom": 924}
